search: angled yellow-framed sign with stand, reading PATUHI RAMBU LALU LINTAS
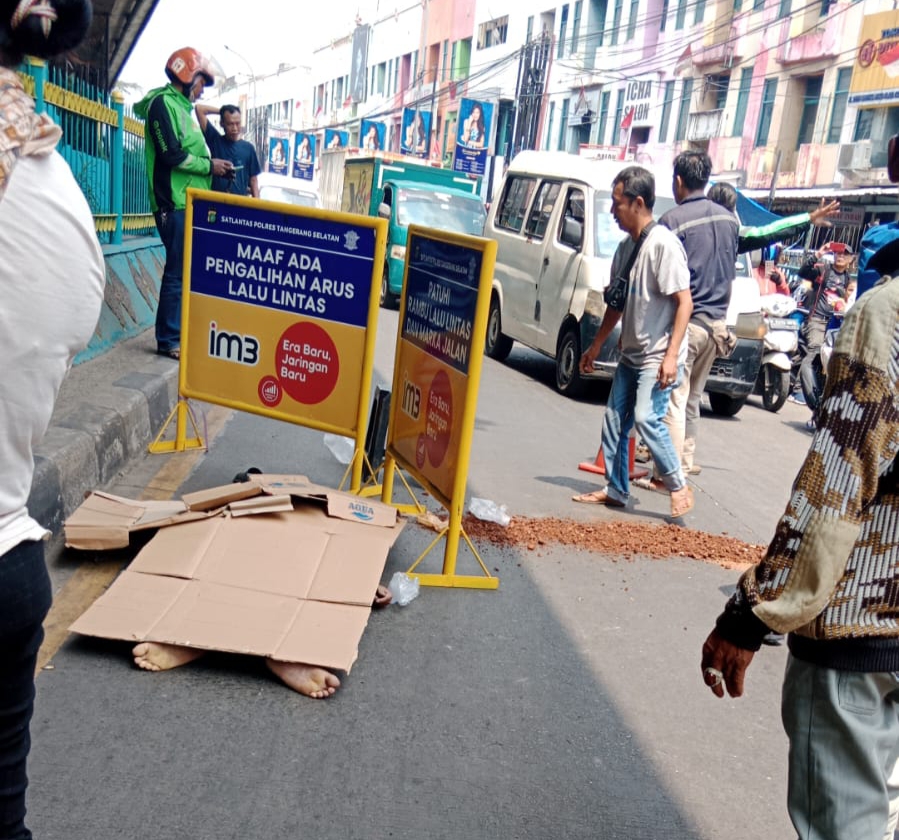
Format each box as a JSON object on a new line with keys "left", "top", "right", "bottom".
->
{"left": 382, "top": 226, "right": 498, "bottom": 588}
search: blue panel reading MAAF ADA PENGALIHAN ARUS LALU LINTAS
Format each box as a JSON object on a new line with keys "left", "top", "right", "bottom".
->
{"left": 190, "top": 198, "right": 375, "bottom": 327}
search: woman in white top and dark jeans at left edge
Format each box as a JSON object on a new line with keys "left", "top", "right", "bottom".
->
{"left": 0, "top": 0, "right": 105, "bottom": 840}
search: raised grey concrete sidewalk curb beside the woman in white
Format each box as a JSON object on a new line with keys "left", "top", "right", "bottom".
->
{"left": 28, "top": 329, "right": 178, "bottom": 559}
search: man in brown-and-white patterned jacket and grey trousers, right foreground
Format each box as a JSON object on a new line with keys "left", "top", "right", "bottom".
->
{"left": 702, "top": 272, "right": 899, "bottom": 840}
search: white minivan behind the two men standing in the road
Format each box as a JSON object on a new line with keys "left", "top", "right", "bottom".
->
{"left": 484, "top": 151, "right": 762, "bottom": 414}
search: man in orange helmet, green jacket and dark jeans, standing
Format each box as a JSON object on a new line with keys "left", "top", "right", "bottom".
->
{"left": 134, "top": 47, "right": 234, "bottom": 359}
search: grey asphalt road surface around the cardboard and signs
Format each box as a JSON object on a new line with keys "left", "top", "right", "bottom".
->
{"left": 29, "top": 311, "right": 810, "bottom": 840}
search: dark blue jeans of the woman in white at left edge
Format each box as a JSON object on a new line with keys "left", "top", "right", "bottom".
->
{"left": 0, "top": 541, "right": 52, "bottom": 840}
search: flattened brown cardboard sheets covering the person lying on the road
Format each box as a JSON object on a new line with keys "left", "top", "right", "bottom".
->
{"left": 66, "top": 475, "right": 403, "bottom": 671}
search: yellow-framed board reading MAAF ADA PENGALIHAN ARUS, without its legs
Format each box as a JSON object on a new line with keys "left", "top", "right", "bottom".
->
{"left": 180, "top": 190, "right": 386, "bottom": 446}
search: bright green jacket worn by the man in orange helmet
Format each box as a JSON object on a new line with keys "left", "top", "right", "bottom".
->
{"left": 134, "top": 84, "right": 212, "bottom": 212}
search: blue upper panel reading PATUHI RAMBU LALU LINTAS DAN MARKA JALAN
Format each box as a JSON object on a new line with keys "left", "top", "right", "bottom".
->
{"left": 401, "top": 235, "right": 484, "bottom": 374}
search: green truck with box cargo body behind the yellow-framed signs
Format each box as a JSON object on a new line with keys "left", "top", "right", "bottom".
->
{"left": 319, "top": 149, "right": 487, "bottom": 308}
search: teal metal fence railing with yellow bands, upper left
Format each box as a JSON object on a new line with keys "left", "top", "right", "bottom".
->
{"left": 20, "top": 58, "right": 156, "bottom": 245}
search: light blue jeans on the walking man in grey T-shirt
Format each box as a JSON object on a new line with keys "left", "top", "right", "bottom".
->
{"left": 602, "top": 362, "right": 687, "bottom": 502}
